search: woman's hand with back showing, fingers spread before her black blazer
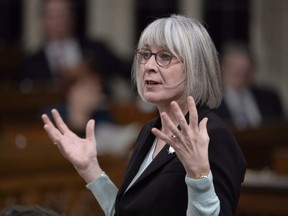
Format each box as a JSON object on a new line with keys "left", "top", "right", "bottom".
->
{"left": 152, "top": 96, "right": 210, "bottom": 179}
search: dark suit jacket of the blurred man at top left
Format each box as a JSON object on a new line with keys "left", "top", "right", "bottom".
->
{"left": 16, "top": 41, "right": 130, "bottom": 82}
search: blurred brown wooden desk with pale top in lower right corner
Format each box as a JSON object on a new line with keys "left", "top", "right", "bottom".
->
{"left": 237, "top": 170, "right": 288, "bottom": 216}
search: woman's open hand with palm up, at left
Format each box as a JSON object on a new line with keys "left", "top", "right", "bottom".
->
{"left": 42, "top": 109, "right": 103, "bottom": 183}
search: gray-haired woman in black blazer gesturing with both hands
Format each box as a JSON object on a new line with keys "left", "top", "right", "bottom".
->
{"left": 42, "top": 15, "right": 246, "bottom": 216}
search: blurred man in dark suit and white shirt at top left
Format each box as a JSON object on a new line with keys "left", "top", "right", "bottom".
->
{"left": 17, "top": 0, "right": 130, "bottom": 90}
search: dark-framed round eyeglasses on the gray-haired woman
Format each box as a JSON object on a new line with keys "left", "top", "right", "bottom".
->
{"left": 135, "top": 49, "right": 180, "bottom": 67}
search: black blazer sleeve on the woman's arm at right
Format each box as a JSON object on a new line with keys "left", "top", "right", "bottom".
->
{"left": 208, "top": 124, "right": 246, "bottom": 215}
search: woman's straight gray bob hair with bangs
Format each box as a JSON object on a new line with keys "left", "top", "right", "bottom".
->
{"left": 132, "top": 15, "right": 222, "bottom": 109}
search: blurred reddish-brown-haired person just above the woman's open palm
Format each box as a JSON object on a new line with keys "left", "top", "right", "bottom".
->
{"left": 45, "top": 62, "right": 114, "bottom": 134}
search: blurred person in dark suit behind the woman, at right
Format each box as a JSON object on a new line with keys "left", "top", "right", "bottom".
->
{"left": 215, "top": 42, "right": 285, "bottom": 130}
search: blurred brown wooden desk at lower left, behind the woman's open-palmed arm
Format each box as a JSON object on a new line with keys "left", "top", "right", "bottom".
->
{"left": 0, "top": 123, "right": 128, "bottom": 216}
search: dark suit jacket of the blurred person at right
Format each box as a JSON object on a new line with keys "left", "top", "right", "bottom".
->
{"left": 214, "top": 87, "right": 285, "bottom": 124}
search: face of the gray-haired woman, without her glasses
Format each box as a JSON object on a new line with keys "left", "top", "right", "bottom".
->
{"left": 139, "top": 45, "right": 185, "bottom": 106}
